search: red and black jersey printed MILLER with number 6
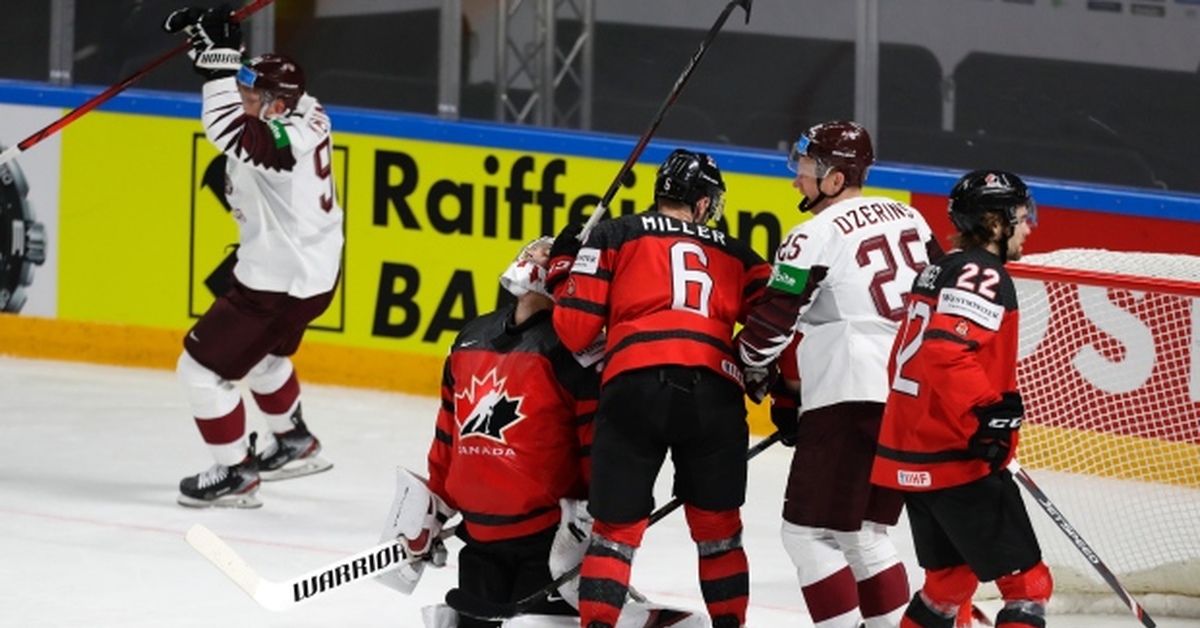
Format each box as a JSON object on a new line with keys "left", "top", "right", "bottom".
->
{"left": 554, "top": 211, "right": 770, "bottom": 383}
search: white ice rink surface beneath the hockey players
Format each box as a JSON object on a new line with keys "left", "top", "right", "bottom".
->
{"left": 0, "top": 358, "right": 1200, "bottom": 628}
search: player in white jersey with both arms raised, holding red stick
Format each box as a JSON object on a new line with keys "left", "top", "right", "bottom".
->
{"left": 163, "top": 5, "right": 343, "bottom": 508}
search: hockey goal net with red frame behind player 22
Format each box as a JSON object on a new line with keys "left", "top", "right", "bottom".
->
{"left": 984, "top": 250, "right": 1200, "bottom": 617}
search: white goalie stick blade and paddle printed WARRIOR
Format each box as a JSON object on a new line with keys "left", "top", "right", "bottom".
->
{"left": 186, "top": 524, "right": 417, "bottom": 611}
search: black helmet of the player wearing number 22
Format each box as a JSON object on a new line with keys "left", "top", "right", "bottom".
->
{"left": 949, "top": 171, "right": 1038, "bottom": 237}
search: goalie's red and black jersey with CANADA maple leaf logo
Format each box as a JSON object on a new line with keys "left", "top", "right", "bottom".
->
{"left": 428, "top": 307, "right": 600, "bottom": 542}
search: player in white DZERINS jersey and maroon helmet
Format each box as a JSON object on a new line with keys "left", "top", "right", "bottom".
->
{"left": 738, "top": 121, "right": 942, "bottom": 628}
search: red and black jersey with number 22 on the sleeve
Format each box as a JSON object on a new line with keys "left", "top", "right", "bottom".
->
{"left": 871, "top": 249, "right": 1018, "bottom": 491}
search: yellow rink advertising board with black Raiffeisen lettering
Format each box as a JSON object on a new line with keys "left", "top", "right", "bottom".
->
{"left": 35, "top": 105, "right": 907, "bottom": 429}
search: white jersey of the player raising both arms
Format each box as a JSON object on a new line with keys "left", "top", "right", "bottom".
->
{"left": 202, "top": 77, "right": 344, "bottom": 298}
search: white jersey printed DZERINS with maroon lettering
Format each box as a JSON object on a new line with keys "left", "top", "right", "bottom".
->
{"left": 773, "top": 197, "right": 940, "bottom": 411}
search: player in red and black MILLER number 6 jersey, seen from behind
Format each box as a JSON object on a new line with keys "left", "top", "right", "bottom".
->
{"left": 546, "top": 149, "right": 770, "bottom": 628}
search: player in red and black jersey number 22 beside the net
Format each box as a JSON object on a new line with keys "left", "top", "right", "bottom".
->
{"left": 871, "top": 171, "right": 1054, "bottom": 628}
